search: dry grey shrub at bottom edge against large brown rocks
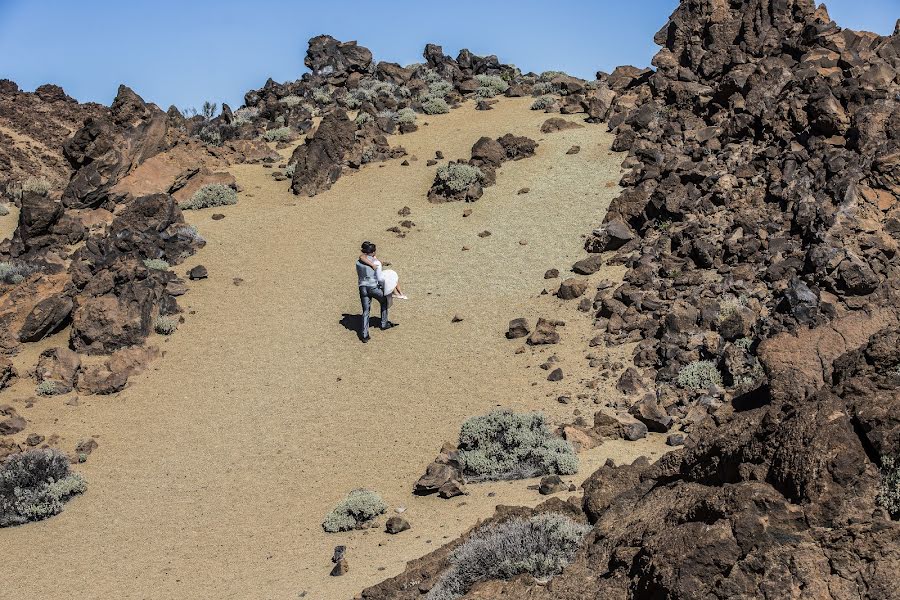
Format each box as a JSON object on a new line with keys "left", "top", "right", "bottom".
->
{"left": 426, "top": 513, "right": 591, "bottom": 600}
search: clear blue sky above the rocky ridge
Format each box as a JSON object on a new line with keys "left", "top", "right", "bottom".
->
{"left": 0, "top": 0, "right": 900, "bottom": 109}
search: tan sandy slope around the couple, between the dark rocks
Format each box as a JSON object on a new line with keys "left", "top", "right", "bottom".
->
{"left": 0, "top": 99, "right": 664, "bottom": 600}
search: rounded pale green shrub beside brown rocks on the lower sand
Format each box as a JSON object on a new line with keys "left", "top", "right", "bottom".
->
{"left": 459, "top": 410, "right": 578, "bottom": 480}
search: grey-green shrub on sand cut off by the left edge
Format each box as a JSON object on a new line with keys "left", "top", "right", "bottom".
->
{"left": 0, "top": 449, "right": 87, "bottom": 527}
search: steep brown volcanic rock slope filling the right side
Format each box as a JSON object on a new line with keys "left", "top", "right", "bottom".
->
{"left": 362, "top": 0, "right": 900, "bottom": 599}
